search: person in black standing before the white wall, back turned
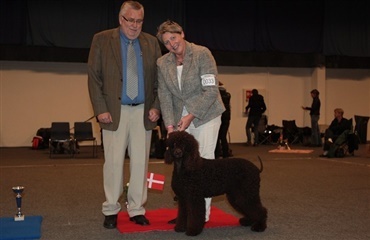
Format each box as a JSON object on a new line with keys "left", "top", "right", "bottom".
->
{"left": 245, "top": 89, "right": 266, "bottom": 146}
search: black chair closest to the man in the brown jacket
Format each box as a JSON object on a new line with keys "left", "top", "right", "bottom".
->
{"left": 73, "top": 122, "right": 97, "bottom": 158}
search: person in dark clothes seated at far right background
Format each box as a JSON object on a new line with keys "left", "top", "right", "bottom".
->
{"left": 320, "top": 108, "right": 352, "bottom": 157}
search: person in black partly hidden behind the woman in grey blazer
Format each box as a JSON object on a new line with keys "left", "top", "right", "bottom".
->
{"left": 215, "top": 82, "right": 232, "bottom": 158}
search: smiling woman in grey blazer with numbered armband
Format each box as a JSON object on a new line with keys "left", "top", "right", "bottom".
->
{"left": 157, "top": 21, "right": 225, "bottom": 221}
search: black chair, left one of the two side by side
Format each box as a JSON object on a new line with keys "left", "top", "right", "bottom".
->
{"left": 49, "top": 122, "right": 75, "bottom": 158}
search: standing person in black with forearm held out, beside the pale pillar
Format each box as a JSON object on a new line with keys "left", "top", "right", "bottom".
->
{"left": 302, "top": 89, "right": 322, "bottom": 147}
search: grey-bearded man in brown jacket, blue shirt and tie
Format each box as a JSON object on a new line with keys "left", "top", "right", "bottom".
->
{"left": 88, "top": 1, "right": 161, "bottom": 229}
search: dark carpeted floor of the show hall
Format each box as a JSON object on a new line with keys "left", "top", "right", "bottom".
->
{"left": 0, "top": 144, "right": 370, "bottom": 240}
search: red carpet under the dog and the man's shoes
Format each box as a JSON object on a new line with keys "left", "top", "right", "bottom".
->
{"left": 117, "top": 207, "right": 239, "bottom": 233}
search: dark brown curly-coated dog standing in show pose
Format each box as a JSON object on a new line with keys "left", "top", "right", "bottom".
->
{"left": 165, "top": 132, "right": 267, "bottom": 236}
